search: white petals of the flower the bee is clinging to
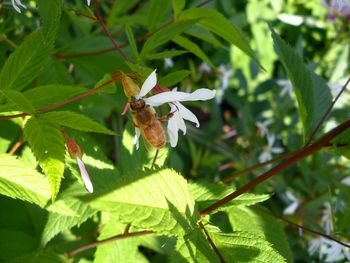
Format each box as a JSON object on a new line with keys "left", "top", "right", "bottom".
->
{"left": 134, "top": 70, "right": 215, "bottom": 147}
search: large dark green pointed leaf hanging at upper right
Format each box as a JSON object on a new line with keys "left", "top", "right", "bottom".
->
{"left": 271, "top": 29, "right": 332, "bottom": 140}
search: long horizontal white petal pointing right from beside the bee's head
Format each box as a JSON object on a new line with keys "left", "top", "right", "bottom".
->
{"left": 145, "top": 89, "right": 216, "bottom": 106}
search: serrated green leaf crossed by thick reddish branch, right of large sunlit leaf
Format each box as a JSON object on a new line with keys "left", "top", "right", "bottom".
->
{"left": 190, "top": 183, "right": 270, "bottom": 210}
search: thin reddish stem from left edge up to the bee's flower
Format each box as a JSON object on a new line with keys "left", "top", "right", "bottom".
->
{"left": 0, "top": 78, "right": 120, "bottom": 120}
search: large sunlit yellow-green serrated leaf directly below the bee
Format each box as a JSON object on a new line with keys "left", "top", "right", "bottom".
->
{"left": 84, "top": 170, "right": 199, "bottom": 235}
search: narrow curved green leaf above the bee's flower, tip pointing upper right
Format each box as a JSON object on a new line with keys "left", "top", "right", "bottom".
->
{"left": 140, "top": 19, "right": 197, "bottom": 57}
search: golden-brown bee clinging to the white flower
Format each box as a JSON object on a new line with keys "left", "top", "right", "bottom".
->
{"left": 130, "top": 97, "right": 166, "bottom": 149}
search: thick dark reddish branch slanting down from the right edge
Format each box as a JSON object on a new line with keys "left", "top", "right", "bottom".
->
{"left": 200, "top": 119, "right": 350, "bottom": 216}
